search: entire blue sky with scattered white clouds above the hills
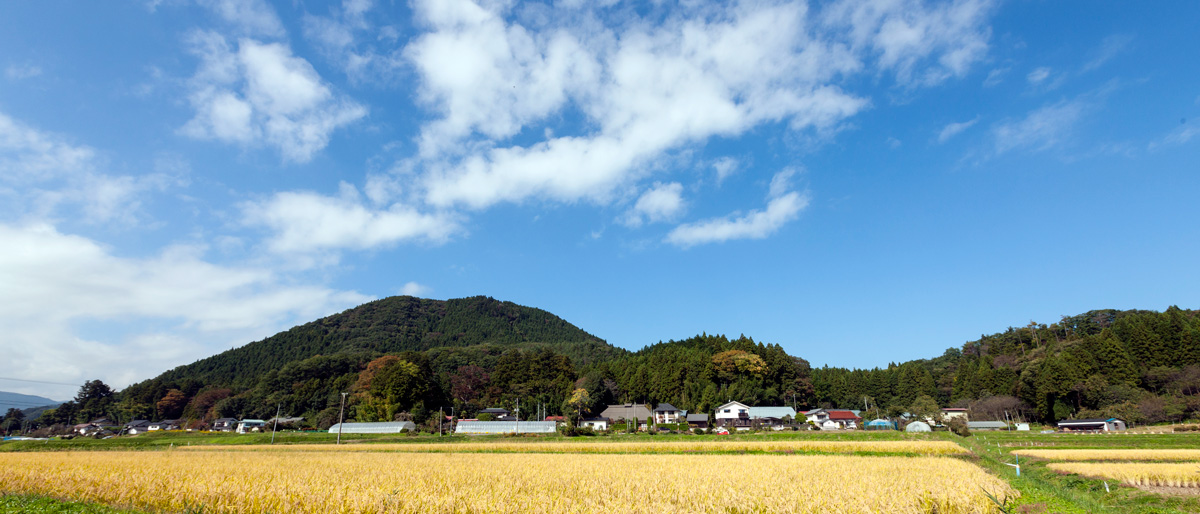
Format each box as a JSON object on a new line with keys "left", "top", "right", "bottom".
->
{"left": 0, "top": 0, "right": 1200, "bottom": 399}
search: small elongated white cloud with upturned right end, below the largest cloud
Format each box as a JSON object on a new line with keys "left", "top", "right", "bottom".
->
{"left": 665, "top": 169, "right": 809, "bottom": 249}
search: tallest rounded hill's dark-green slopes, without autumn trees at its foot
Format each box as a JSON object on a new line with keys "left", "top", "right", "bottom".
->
{"left": 110, "top": 297, "right": 629, "bottom": 416}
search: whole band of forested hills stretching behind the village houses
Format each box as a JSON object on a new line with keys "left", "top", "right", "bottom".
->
{"left": 21, "top": 302, "right": 1200, "bottom": 426}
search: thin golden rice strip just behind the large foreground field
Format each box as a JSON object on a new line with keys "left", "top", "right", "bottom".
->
{"left": 181, "top": 441, "right": 970, "bottom": 455}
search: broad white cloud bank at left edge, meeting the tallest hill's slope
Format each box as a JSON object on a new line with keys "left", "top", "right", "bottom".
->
{"left": 0, "top": 223, "right": 370, "bottom": 394}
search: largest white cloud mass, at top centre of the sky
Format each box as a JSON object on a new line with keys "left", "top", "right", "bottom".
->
{"left": 408, "top": 2, "right": 868, "bottom": 209}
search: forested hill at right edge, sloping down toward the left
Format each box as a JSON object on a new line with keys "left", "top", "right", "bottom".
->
{"left": 812, "top": 306, "right": 1200, "bottom": 423}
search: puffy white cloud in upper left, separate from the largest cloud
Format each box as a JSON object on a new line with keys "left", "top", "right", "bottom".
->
{"left": 180, "top": 32, "right": 366, "bottom": 162}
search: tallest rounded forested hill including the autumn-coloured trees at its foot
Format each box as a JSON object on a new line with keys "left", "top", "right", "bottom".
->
{"left": 79, "top": 297, "right": 628, "bottom": 423}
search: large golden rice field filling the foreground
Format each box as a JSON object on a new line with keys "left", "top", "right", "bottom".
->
{"left": 0, "top": 452, "right": 1016, "bottom": 514}
